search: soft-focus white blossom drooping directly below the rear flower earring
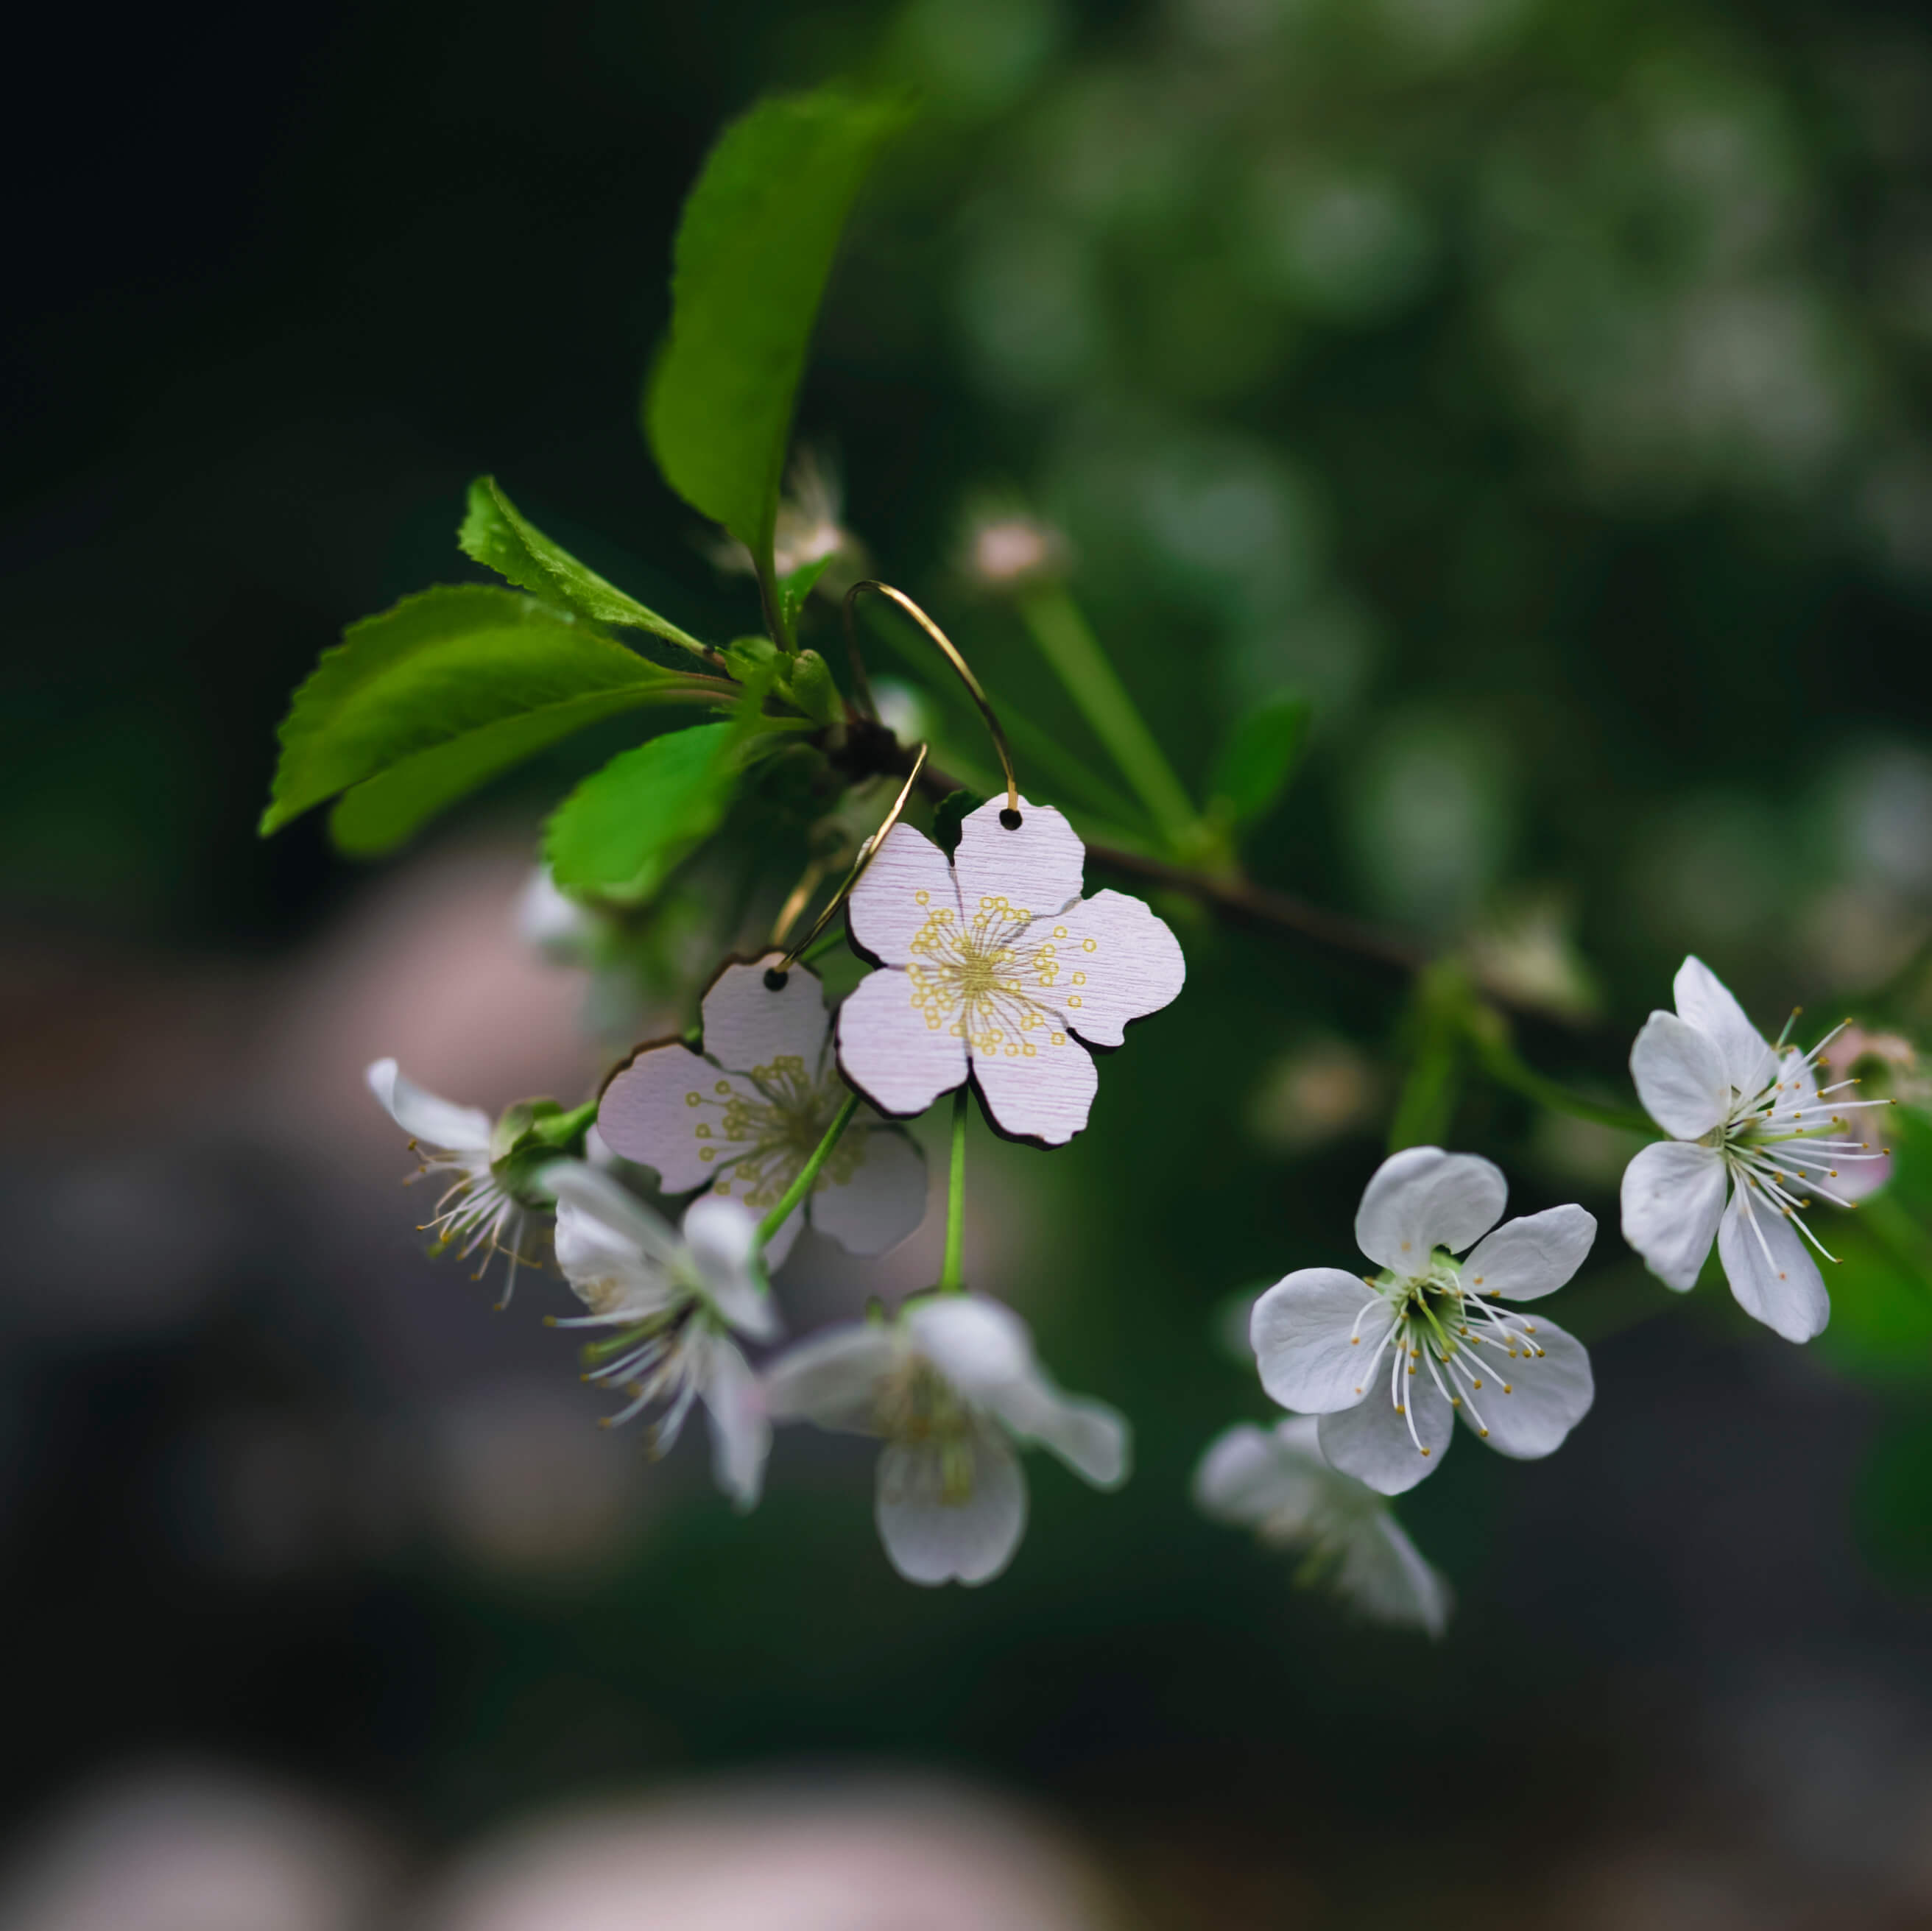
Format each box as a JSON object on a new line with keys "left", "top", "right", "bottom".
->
{"left": 543, "top": 1160, "right": 778, "bottom": 1508}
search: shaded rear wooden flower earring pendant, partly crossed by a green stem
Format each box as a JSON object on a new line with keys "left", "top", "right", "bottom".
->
{"left": 597, "top": 952, "right": 926, "bottom": 1267}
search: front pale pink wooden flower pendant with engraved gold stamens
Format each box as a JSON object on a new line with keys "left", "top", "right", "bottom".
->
{"left": 839, "top": 797, "right": 1186, "bottom": 1147}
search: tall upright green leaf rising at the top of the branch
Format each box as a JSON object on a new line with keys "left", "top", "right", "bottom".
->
{"left": 645, "top": 87, "right": 904, "bottom": 566}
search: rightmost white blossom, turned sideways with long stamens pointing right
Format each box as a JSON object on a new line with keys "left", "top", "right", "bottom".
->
{"left": 1623, "top": 958, "right": 1886, "bottom": 1340}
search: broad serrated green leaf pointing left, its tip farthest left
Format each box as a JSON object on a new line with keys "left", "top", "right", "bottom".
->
{"left": 261, "top": 583, "right": 702, "bottom": 850}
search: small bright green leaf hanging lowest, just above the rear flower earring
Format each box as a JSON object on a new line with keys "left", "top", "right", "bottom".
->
{"left": 543, "top": 724, "right": 742, "bottom": 904}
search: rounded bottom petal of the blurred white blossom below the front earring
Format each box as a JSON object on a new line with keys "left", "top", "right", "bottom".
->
{"left": 873, "top": 1423, "right": 1026, "bottom": 1585}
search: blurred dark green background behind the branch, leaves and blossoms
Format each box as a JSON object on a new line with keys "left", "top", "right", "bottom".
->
{"left": 0, "top": 0, "right": 1932, "bottom": 1927}
